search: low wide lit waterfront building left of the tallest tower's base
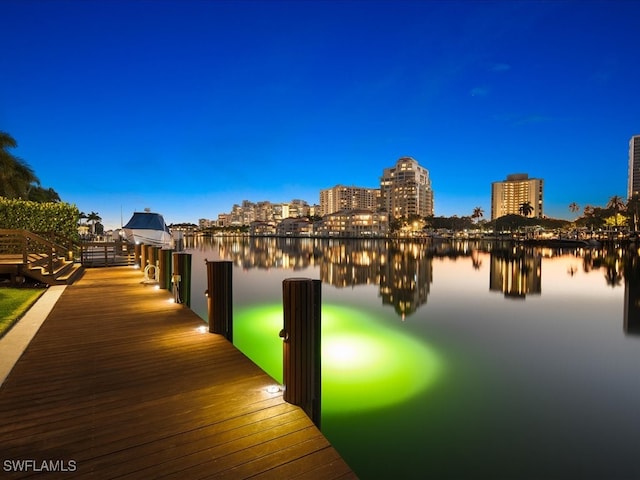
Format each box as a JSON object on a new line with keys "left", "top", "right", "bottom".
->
{"left": 316, "top": 209, "right": 389, "bottom": 237}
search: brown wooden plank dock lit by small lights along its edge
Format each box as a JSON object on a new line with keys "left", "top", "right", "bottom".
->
{"left": 0, "top": 267, "right": 356, "bottom": 480}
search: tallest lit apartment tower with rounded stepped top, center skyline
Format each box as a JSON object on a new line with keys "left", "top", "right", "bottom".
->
{"left": 380, "top": 157, "right": 433, "bottom": 218}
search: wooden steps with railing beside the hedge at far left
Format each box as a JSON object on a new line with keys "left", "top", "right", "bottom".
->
{"left": 0, "top": 229, "right": 83, "bottom": 285}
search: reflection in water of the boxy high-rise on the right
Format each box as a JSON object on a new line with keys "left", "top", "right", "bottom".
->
{"left": 489, "top": 245, "right": 542, "bottom": 299}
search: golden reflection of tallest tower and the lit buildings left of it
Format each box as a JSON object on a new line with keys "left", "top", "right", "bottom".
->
{"left": 189, "top": 236, "right": 456, "bottom": 319}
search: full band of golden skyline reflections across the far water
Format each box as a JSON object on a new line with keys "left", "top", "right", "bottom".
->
{"left": 188, "top": 237, "right": 640, "bottom": 320}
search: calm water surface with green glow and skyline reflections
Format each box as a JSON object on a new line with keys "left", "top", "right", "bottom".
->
{"left": 187, "top": 238, "right": 640, "bottom": 479}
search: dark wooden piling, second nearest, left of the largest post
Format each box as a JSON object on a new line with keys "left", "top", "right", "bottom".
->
{"left": 205, "top": 260, "right": 233, "bottom": 342}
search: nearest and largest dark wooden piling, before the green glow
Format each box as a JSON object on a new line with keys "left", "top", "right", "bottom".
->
{"left": 280, "top": 278, "right": 321, "bottom": 428}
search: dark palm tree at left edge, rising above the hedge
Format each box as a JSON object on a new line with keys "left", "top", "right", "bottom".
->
{"left": 0, "top": 131, "right": 40, "bottom": 199}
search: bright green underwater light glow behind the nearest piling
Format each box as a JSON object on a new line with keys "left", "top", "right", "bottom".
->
{"left": 233, "top": 304, "right": 442, "bottom": 414}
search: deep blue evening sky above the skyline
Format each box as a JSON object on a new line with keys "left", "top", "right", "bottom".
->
{"left": 0, "top": 0, "right": 640, "bottom": 228}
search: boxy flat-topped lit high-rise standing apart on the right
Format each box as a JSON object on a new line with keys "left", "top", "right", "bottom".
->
{"left": 491, "top": 173, "right": 543, "bottom": 220}
